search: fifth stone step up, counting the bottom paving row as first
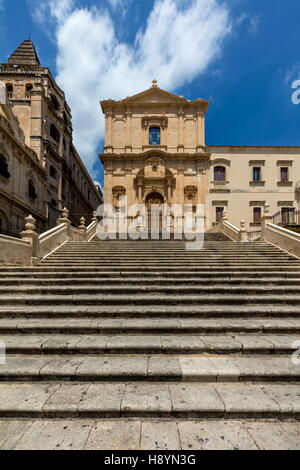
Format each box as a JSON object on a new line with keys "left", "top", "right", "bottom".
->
{"left": 0, "top": 315, "right": 300, "bottom": 339}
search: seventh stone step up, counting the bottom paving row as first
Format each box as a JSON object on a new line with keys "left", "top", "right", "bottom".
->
{"left": 0, "top": 289, "right": 300, "bottom": 306}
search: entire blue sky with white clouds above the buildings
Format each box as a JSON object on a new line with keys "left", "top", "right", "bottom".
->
{"left": 0, "top": 0, "right": 300, "bottom": 187}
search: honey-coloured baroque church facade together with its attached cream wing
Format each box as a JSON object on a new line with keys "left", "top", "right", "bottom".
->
{"left": 100, "top": 80, "right": 300, "bottom": 231}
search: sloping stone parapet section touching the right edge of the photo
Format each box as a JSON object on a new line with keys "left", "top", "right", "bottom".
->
{"left": 264, "top": 222, "right": 300, "bottom": 258}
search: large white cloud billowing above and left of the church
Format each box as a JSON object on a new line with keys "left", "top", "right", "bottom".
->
{"left": 31, "top": 0, "right": 230, "bottom": 176}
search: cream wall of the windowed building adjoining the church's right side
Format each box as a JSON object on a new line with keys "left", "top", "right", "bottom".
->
{"left": 207, "top": 147, "right": 300, "bottom": 231}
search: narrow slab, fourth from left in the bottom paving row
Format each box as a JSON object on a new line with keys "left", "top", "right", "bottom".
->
{"left": 140, "top": 420, "right": 181, "bottom": 450}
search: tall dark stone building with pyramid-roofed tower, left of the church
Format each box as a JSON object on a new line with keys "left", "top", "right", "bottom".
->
{"left": 0, "top": 41, "right": 102, "bottom": 232}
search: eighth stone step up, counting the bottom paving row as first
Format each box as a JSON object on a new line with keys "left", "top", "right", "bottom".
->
{"left": 0, "top": 282, "right": 300, "bottom": 294}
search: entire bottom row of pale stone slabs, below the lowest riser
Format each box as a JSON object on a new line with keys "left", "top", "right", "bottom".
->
{"left": 0, "top": 416, "right": 300, "bottom": 450}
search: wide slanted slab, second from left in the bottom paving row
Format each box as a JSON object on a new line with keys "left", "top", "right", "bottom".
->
{"left": 13, "top": 420, "right": 94, "bottom": 450}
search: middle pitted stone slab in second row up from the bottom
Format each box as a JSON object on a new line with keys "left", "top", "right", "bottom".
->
{"left": 121, "top": 384, "right": 172, "bottom": 415}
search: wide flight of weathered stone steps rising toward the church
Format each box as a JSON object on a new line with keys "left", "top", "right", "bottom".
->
{"left": 0, "top": 239, "right": 300, "bottom": 440}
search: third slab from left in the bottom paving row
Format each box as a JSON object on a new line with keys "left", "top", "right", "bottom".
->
{"left": 84, "top": 419, "right": 142, "bottom": 450}
